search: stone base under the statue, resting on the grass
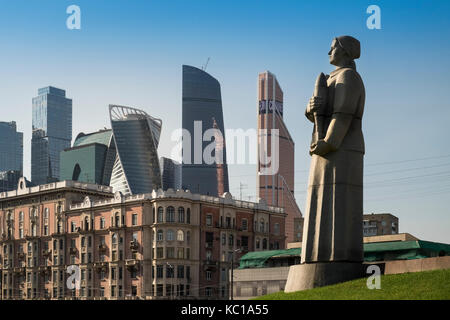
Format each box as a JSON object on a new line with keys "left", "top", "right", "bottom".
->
{"left": 284, "top": 262, "right": 365, "bottom": 292}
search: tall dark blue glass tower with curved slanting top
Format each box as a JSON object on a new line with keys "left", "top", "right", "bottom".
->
{"left": 182, "top": 66, "right": 229, "bottom": 196}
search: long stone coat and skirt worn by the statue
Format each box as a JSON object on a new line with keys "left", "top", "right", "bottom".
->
{"left": 301, "top": 67, "right": 365, "bottom": 263}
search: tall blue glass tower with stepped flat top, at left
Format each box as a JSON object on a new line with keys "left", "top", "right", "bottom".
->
{"left": 31, "top": 87, "right": 72, "bottom": 184}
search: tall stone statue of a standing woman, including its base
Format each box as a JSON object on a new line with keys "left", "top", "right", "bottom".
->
{"left": 286, "top": 36, "right": 365, "bottom": 292}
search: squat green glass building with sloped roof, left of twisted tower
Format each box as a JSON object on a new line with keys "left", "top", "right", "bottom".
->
{"left": 61, "top": 129, "right": 116, "bottom": 186}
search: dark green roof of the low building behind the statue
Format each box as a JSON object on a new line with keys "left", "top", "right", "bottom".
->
{"left": 239, "top": 240, "right": 450, "bottom": 269}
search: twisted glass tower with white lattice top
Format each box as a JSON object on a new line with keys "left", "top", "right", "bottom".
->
{"left": 109, "top": 105, "right": 162, "bottom": 195}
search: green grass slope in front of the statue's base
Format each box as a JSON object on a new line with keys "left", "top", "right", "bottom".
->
{"left": 256, "top": 269, "right": 450, "bottom": 300}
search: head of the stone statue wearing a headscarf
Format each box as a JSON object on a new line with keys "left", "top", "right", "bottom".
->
{"left": 328, "top": 36, "right": 361, "bottom": 66}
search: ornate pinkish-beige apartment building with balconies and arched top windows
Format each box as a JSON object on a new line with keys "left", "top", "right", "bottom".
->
{"left": 0, "top": 180, "right": 286, "bottom": 300}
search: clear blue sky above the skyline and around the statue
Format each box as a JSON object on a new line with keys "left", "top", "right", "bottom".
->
{"left": 0, "top": 0, "right": 450, "bottom": 243}
